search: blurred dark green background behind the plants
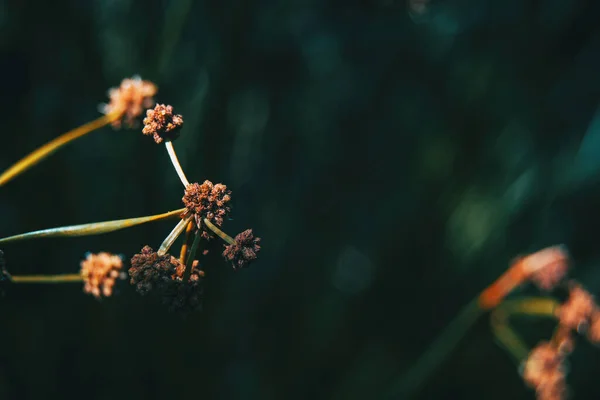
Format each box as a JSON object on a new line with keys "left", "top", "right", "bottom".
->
{"left": 0, "top": 0, "right": 600, "bottom": 400}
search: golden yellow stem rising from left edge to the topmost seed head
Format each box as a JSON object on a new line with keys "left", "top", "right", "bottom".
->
{"left": 0, "top": 113, "right": 122, "bottom": 186}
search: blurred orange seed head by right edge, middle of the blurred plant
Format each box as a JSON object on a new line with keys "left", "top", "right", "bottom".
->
{"left": 558, "top": 283, "right": 597, "bottom": 331}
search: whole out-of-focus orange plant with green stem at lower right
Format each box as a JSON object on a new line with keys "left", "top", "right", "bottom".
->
{"left": 390, "top": 246, "right": 600, "bottom": 400}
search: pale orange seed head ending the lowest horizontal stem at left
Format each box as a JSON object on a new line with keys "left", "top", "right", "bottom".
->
{"left": 80, "top": 252, "right": 123, "bottom": 299}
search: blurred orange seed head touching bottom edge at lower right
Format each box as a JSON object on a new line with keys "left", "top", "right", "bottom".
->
{"left": 523, "top": 342, "right": 567, "bottom": 400}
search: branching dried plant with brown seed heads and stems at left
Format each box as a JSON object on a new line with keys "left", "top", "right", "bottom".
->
{"left": 0, "top": 83, "right": 260, "bottom": 312}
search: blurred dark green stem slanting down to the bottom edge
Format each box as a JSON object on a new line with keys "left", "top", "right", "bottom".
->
{"left": 386, "top": 299, "right": 485, "bottom": 399}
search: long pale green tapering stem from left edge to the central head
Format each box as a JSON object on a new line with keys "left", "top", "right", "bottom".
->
{"left": 0, "top": 208, "right": 185, "bottom": 244}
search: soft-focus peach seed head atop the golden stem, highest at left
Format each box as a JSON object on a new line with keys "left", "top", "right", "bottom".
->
{"left": 101, "top": 76, "right": 158, "bottom": 129}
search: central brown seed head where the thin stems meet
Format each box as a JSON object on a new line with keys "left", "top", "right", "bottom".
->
{"left": 182, "top": 181, "right": 231, "bottom": 238}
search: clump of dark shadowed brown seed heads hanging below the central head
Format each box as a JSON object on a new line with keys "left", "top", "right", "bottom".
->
{"left": 129, "top": 246, "right": 204, "bottom": 312}
